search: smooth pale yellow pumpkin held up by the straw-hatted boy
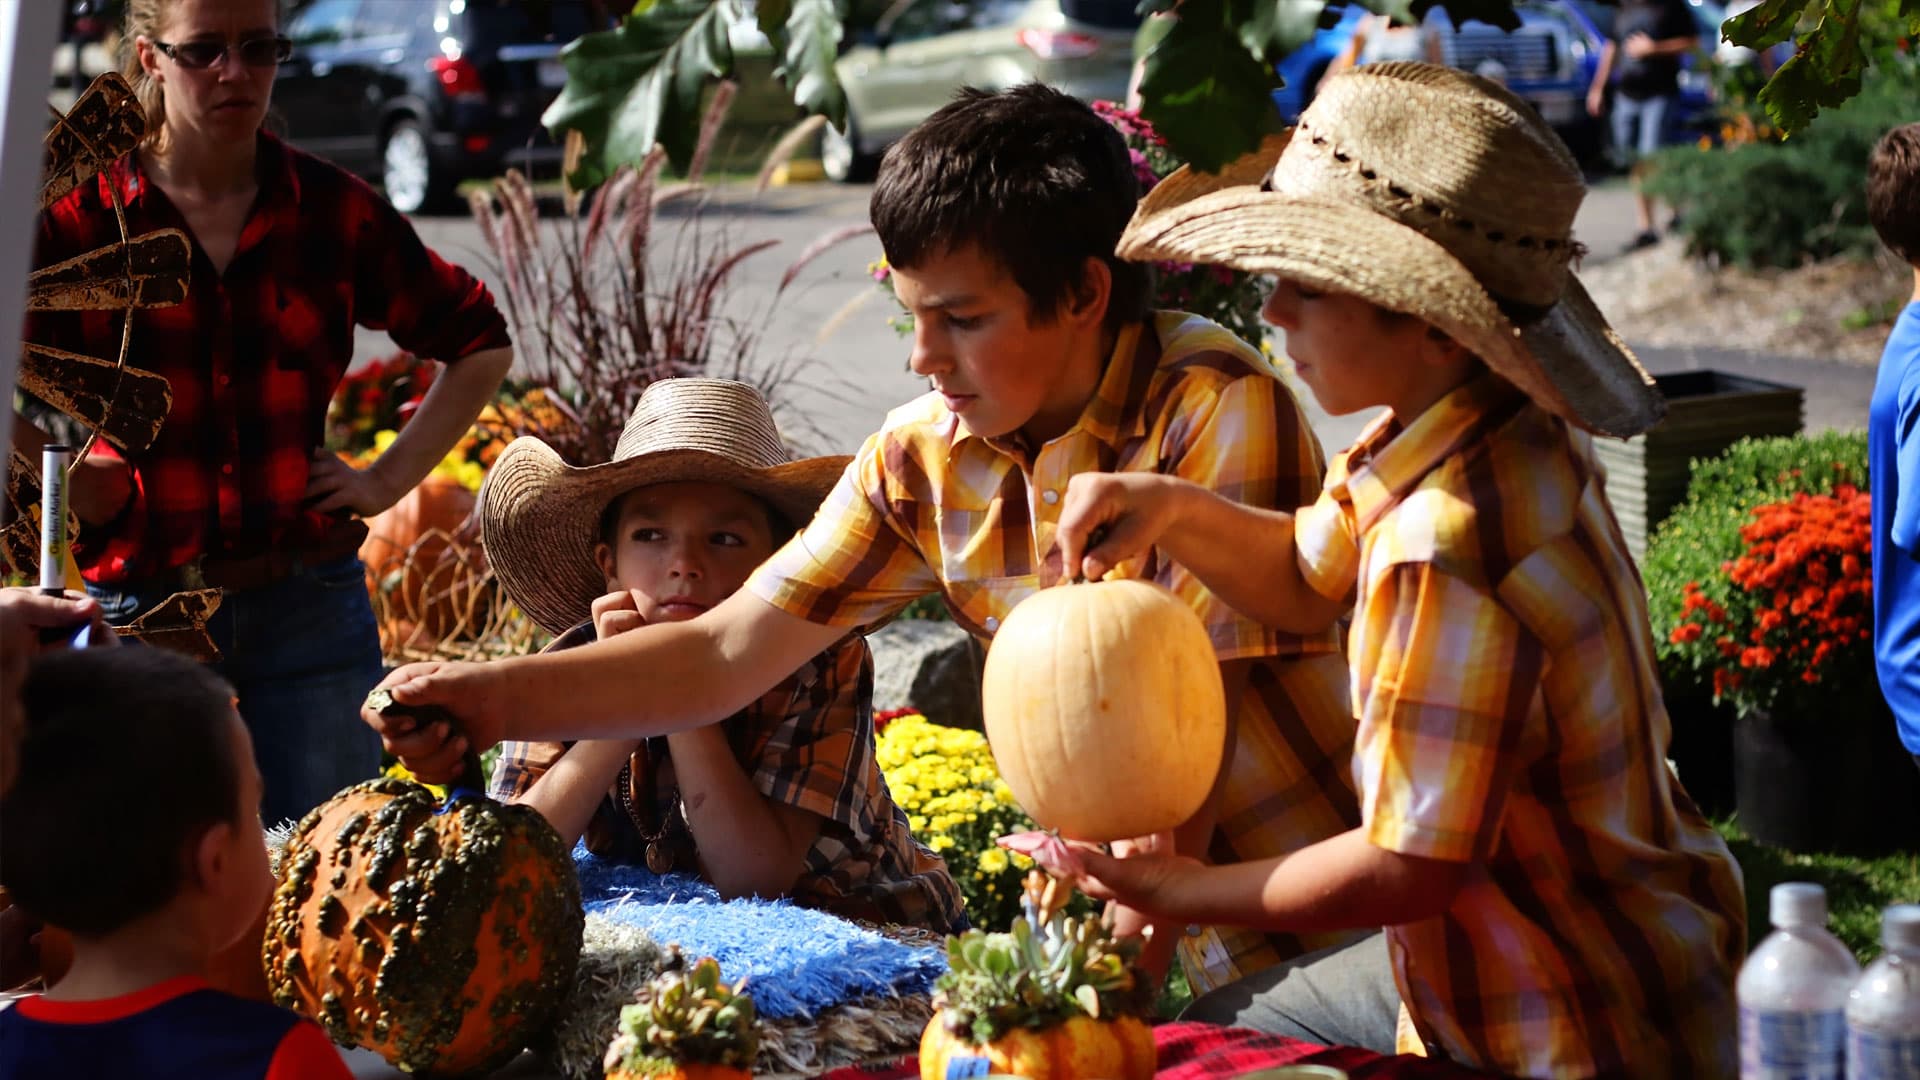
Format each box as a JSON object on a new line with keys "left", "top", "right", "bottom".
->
{"left": 981, "top": 580, "right": 1227, "bottom": 842}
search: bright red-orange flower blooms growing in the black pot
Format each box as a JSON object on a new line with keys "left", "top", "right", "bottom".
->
{"left": 1667, "top": 484, "right": 1876, "bottom": 715}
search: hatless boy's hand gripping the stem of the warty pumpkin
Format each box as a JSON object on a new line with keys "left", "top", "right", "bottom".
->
{"left": 361, "top": 663, "right": 505, "bottom": 784}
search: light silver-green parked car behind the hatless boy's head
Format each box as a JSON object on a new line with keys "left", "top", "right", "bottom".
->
{"left": 820, "top": 0, "right": 1140, "bottom": 181}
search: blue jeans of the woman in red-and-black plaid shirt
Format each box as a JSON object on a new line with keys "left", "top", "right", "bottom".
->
{"left": 86, "top": 555, "right": 384, "bottom": 826}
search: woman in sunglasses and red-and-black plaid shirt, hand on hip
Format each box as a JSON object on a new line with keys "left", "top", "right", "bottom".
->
{"left": 13, "top": 0, "right": 513, "bottom": 821}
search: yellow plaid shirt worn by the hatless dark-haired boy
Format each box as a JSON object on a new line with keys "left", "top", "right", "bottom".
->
{"left": 747, "top": 311, "right": 1359, "bottom": 990}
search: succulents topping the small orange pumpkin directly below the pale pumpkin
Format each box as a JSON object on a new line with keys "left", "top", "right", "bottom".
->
{"left": 933, "top": 871, "right": 1154, "bottom": 1045}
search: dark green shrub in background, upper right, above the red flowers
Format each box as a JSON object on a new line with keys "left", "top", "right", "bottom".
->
{"left": 1645, "top": 61, "right": 1920, "bottom": 269}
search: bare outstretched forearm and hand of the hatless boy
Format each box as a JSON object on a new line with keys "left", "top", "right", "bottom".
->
{"left": 361, "top": 590, "right": 847, "bottom": 782}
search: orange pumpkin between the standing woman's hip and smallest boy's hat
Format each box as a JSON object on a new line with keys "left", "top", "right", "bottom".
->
{"left": 359, "top": 477, "right": 486, "bottom": 653}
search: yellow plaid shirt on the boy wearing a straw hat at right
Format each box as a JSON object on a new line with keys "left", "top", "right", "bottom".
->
{"left": 1296, "top": 375, "right": 1747, "bottom": 1078}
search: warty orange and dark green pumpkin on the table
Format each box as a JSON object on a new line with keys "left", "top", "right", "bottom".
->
{"left": 265, "top": 690, "right": 586, "bottom": 1076}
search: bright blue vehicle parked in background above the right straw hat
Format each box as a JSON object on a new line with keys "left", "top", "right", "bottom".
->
{"left": 1273, "top": 0, "right": 1724, "bottom": 161}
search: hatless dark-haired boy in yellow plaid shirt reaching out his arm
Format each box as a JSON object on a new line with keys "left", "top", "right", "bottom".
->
{"left": 367, "top": 85, "right": 1359, "bottom": 988}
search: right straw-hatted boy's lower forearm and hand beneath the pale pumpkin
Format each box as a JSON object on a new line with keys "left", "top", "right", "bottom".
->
{"left": 1035, "top": 828, "right": 1471, "bottom": 934}
